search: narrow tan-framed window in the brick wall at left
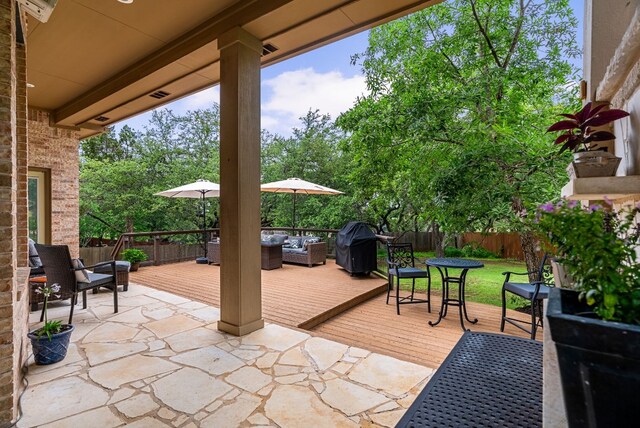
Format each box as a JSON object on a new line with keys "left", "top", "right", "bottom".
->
{"left": 27, "top": 169, "right": 51, "bottom": 244}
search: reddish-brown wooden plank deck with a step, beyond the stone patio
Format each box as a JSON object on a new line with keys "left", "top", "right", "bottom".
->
{"left": 131, "top": 260, "right": 542, "bottom": 368}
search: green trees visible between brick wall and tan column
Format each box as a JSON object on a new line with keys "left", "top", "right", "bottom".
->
{"left": 80, "top": 105, "right": 220, "bottom": 241}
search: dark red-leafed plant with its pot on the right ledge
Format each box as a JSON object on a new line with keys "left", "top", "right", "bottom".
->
{"left": 547, "top": 103, "right": 629, "bottom": 179}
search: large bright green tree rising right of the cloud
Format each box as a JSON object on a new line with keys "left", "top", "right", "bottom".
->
{"left": 338, "top": 0, "right": 578, "bottom": 266}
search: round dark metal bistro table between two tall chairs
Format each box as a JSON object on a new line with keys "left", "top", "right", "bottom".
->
{"left": 425, "top": 257, "right": 484, "bottom": 330}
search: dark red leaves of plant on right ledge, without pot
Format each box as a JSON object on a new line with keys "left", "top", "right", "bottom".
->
{"left": 547, "top": 103, "right": 629, "bottom": 153}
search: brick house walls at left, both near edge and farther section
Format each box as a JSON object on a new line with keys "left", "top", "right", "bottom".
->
{"left": 0, "top": 0, "right": 79, "bottom": 425}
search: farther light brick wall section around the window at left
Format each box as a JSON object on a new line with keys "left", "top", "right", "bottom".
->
{"left": 28, "top": 109, "right": 80, "bottom": 257}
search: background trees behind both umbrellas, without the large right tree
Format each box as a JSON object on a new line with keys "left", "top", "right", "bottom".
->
{"left": 80, "top": 104, "right": 354, "bottom": 241}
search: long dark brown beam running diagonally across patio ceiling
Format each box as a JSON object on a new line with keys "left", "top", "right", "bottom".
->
{"left": 53, "top": 0, "right": 292, "bottom": 125}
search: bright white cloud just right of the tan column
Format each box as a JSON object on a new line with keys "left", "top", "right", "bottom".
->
{"left": 262, "top": 68, "right": 366, "bottom": 135}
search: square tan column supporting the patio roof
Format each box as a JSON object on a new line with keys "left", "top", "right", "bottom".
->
{"left": 218, "top": 28, "right": 264, "bottom": 336}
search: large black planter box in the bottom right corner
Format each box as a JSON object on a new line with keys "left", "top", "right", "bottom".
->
{"left": 547, "top": 288, "right": 640, "bottom": 428}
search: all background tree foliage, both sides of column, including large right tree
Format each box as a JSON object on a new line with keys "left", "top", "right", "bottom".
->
{"left": 81, "top": 0, "right": 579, "bottom": 265}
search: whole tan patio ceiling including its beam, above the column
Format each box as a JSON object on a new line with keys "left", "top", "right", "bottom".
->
{"left": 27, "top": 0, "right": 442, "bottom": 137}
